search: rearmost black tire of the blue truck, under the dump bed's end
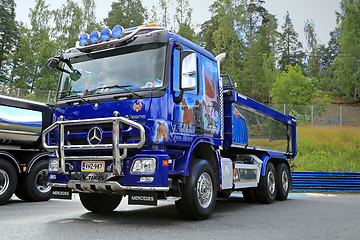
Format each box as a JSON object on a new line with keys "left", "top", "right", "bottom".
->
{"left": 276, "top": 163, "right": 290, "bottom": 201}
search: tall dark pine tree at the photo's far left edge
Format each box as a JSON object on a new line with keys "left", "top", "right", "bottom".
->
{"left": 0, "top": 0, "right": 18, "bottom": 83}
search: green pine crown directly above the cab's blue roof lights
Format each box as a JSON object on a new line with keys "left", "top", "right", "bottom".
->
{"left": 104, "top": 0, "right": 147, "bottom": 28}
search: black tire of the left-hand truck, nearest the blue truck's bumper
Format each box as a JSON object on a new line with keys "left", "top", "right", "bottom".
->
{"left": 15, "top": 160, "right": 51, "bottom": 202}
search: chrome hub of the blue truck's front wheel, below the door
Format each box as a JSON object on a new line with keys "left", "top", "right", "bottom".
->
{"left": 196, "top": 172, "right": 214, "bottom": 208}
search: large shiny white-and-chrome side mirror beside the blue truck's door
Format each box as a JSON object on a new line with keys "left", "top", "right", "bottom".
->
{"left": 180, "top": 50, "right": 197, "bottom": 91}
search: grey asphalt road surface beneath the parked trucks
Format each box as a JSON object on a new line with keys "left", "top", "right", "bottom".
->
{"left": 0, "top": 194, "right": 360, "bottom": 240}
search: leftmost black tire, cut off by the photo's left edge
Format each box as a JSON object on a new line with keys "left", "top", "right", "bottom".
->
{"left": 0, "top": 159, "right": 18, "bottom": 205}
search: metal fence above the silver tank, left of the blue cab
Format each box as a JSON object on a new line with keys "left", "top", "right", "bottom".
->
{"left": 0, "top": 84, "right": 56, "bottom": 104}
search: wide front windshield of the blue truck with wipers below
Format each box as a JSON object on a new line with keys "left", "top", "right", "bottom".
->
{"left": 58, "top": 44, "right": 166, "bottom": 99}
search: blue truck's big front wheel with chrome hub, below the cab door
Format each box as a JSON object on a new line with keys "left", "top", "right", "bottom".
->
{"left": 175, "top": 160, "right": 217, "bottom": 220}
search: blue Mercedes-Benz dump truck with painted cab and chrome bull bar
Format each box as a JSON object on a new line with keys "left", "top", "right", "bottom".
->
{"left": 42, "top": 25, "right": 297, "bottom": 219}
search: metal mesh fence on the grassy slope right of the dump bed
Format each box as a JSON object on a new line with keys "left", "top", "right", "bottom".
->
{"left": 271, "top": 104, "right": 360, "bottom": 127}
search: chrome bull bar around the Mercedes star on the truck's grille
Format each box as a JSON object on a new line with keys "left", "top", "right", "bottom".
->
{"left": 41, "top": 116, "right": 145, "bottom": 176}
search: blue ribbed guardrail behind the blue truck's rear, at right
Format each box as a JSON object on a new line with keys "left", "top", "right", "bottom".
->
{"left": 291, "top": 171, "right": 360, "bottom": 192}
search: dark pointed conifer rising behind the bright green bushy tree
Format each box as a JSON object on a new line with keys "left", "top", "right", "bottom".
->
{"left": 278, "top": 12, "right": 305, "bottom": 71}
